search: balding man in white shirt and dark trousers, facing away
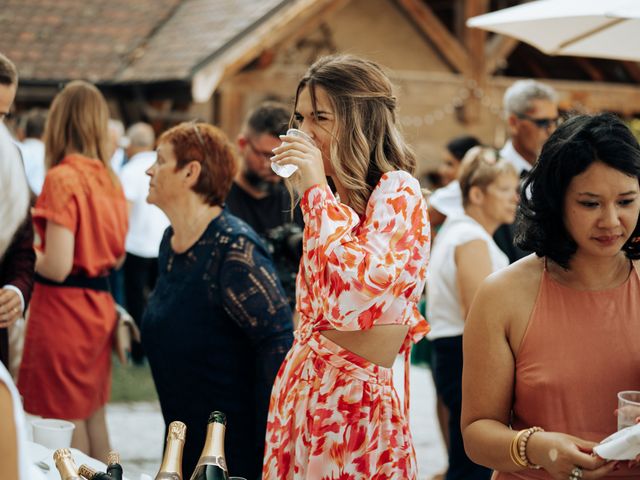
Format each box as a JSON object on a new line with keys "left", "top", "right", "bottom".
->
{"left": 120, "top": 123, "right": 169, "bottom": 363}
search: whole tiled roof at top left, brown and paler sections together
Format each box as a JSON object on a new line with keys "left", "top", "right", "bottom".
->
{"left": 0, "top": 0, "right": 292, "bottom": 83}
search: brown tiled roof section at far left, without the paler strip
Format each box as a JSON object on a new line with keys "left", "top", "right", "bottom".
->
{"left": 0, "top": 0, "right": 181, "bottom": 82}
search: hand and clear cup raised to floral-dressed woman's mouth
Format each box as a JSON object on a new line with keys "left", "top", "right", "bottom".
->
{"left": 271, "top": 128, "right": 327, "bottom": 194}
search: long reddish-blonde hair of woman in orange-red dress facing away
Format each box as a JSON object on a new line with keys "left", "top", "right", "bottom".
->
{"left": 44, "top": 80, "right": 117, "bottom": 183}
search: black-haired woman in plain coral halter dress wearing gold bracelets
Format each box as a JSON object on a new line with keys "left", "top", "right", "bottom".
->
{"left": 461, "top": 114, "right": 640, "bottom": 480}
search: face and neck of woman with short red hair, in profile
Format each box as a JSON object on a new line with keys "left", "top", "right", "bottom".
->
{"left": 146, "top": 142, "right": 184, "bottom": 210}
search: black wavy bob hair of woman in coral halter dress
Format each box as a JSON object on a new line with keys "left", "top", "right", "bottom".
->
{"left": 515, "top": 113, "right": 640, "bottom": 269}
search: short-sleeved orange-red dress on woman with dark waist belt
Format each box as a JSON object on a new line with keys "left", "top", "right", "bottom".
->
{"left": 18, "top": 155, "right": 127, "bottom": 420}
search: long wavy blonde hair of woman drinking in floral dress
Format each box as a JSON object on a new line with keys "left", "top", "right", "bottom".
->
{"left": 292, "top": 55, "right": 416, "bottom": 215}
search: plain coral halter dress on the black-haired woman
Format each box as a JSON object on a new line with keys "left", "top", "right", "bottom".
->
{"left": 494, "top": 267, "right": 640, "bottom": 480}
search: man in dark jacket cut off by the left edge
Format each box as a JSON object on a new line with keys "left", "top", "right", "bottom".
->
{"left": 0, "top": 53, "right": 36, "bottom": 369}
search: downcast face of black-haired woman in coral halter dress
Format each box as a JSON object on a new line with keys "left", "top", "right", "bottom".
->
{"left": 564, "top": 162, "right": 640, "bottom": 257}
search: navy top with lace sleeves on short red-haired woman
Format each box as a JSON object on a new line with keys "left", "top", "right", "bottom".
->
{"left": 142, "top": 210, "right": 293, "bottom": 480}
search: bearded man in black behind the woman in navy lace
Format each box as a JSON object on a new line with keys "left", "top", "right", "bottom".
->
{"left": 226, "top": 102, "right": 304, "bottom": 310}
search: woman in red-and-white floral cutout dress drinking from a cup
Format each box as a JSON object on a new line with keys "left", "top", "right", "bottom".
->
{"left": 263, "top": 56, "right": 429, "bottom": 480}
